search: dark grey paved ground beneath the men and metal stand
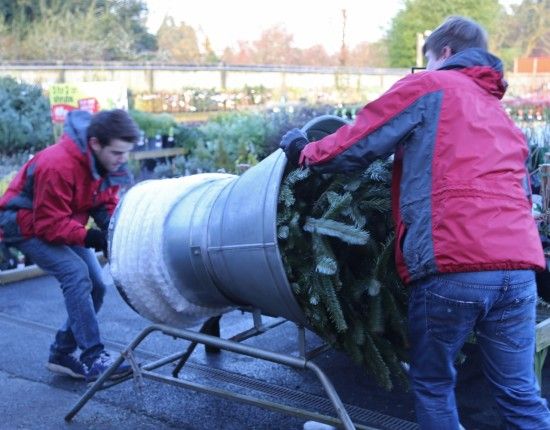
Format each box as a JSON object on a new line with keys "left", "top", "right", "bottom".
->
{"left": 0, "top": 268, "right": 550, "bottom": 430}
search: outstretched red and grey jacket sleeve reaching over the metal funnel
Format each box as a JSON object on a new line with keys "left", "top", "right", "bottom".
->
{"left": 300, "top": 74, "right": 436, "bottom": 173}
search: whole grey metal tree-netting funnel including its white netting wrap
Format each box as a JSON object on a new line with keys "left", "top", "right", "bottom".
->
{"left": 110, "top": 116, "right": 344, "bottom": 327}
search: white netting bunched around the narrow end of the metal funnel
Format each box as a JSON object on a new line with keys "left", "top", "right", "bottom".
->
{"left": 110, "top": 174, "right": 235, "bottom": 327}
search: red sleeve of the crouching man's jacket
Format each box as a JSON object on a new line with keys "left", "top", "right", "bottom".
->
{"left": 33, "top": 166, "right": 86, "bottom": 245}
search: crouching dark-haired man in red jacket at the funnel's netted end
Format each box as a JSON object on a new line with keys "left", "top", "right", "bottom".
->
{"left": 0, "top": 109, "right": 139, "bottom": 380}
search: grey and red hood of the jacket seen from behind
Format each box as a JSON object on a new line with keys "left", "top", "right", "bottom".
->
{"left": 438, "top": 48, "right": 508, "bottom": 99}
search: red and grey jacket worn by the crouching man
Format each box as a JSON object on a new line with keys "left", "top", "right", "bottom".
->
{"left": 0, "top": 111, "right": 131, "bottom": 245}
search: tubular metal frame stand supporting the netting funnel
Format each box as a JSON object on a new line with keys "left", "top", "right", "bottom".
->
{"left": 65, "top": 311, "right": 368, "bottom": 430}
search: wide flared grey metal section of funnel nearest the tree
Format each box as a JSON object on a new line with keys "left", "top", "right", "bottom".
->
{"left": 206, "top": 150, "right": 305, "bottom": 324}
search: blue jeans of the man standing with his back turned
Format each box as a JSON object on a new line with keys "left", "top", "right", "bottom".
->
{"left": 409, "top": 270, "right": 550, "bottom": 430}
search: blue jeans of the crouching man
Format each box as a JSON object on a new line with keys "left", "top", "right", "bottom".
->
{"left": 13, "top": 238, "right": 106, "bottom": 365}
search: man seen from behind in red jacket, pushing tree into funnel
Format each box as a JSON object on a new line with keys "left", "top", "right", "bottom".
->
{"left": 281, "top": 17, "right": 550, "bottom": 430}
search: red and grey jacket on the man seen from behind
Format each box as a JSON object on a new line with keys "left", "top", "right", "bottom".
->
{"left": 300, "top": 49, "right": 545, "bottom": 282}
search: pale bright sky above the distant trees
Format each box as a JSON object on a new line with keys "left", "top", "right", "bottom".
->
{"left": 147, "top": 0, "right": 519, "bottom": 53}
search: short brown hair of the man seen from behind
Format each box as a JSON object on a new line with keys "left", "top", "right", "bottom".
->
{"left": 422, "top": 16, "right": 487, "bottom": 56}
